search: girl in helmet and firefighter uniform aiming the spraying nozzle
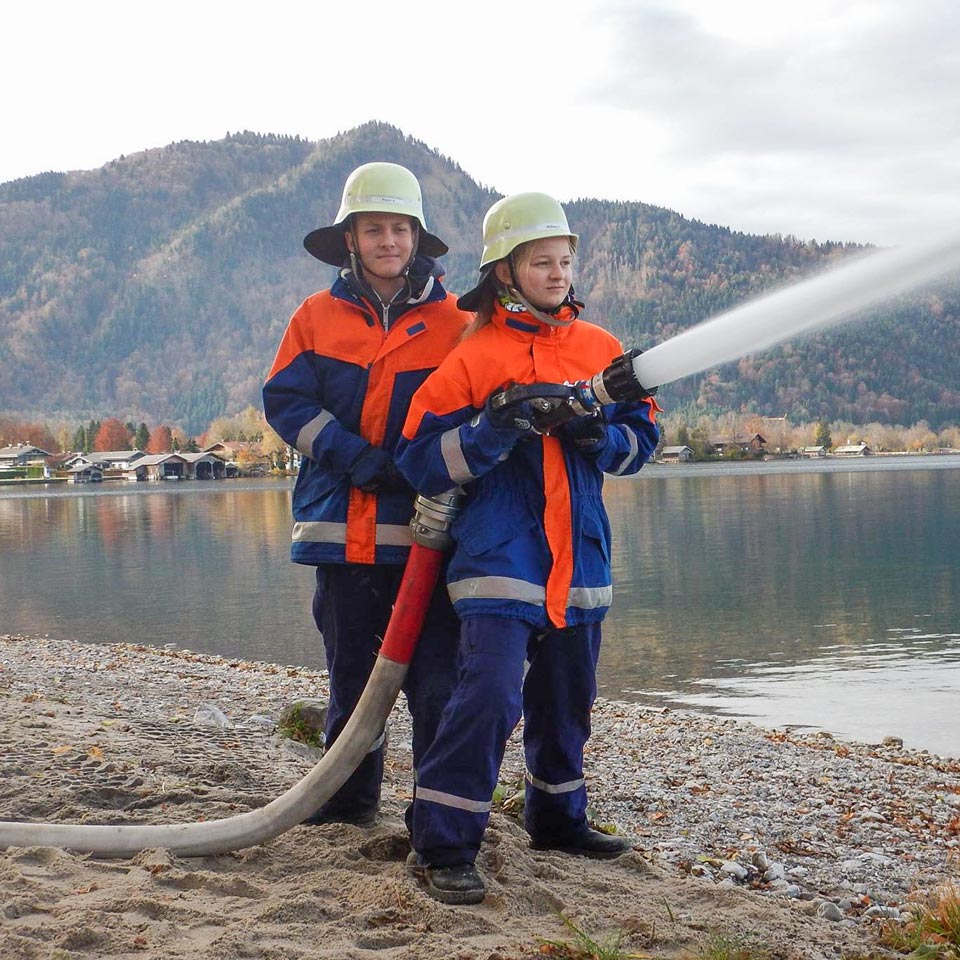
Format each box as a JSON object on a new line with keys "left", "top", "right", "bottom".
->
{"left": 397, "top": 193, "right": 658, "bottom": 903}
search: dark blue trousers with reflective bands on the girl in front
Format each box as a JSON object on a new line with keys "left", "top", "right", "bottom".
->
{"left": 412, "top": 617, "right": 600, "bottom": 866}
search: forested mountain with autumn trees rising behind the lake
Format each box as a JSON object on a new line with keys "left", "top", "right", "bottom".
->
{"left": 0, "top": 123, "right": 960, "bottom": 433}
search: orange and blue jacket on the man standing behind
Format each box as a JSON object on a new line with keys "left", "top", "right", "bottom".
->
{"left": 263, "top": 257, "right": 470, "bottom": 564}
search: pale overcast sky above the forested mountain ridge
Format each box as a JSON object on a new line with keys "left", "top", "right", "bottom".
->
{"left": 0, "top": 0, "right": 960, "bottom": 244}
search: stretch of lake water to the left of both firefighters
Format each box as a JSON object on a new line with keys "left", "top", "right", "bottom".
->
{"left": 0, "top": 481, "right": 323, "bottom": 668}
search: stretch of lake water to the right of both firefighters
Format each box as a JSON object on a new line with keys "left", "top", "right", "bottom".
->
{"left": 601, "top": 464, "right": 960, "bottom": 754}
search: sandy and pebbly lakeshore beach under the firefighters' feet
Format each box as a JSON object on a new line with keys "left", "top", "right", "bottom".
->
{"left": 0, "top": 635, "right": 960, "bottom": 960}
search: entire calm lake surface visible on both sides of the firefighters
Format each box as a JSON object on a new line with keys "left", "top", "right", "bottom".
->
{"left": 0, "top": 456, "right": 960, "bottom": 756}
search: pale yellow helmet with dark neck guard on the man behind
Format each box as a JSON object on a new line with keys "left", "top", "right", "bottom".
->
{"left": 303, "top": 162, "right": 448, "bottom": 267}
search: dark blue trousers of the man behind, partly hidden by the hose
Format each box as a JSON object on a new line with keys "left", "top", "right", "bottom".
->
{"left": 313, "top": 564, "right": 459, "bottom": 816}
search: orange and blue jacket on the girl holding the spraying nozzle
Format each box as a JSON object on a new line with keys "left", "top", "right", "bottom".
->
{"left": 397, "top": 303, "right": 659, "bottom": 629}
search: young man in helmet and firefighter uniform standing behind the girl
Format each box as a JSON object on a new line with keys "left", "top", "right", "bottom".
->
{"left": 263, "top": 163, "right": 470, "bottom": 826}
